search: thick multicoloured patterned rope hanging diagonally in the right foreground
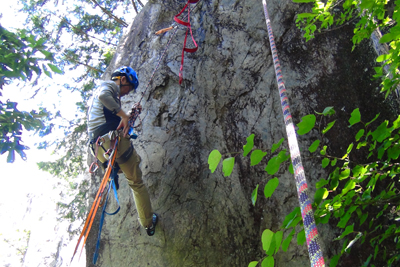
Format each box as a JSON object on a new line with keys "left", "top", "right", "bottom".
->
{"left": 263, "top": 0, "right": 325, "bottom": 267}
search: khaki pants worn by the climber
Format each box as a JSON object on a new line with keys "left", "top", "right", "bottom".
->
{"left": 97, "top": 136, "right": 153, "bottom": 227}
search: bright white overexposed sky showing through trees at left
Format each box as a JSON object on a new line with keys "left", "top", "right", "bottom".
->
{"left": 0, "top": 0, "right": 86, "bottom": 267}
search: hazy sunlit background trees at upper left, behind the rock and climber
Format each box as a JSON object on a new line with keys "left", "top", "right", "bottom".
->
{"left": 0, "top": 0, "right": 143, "bottom": 221}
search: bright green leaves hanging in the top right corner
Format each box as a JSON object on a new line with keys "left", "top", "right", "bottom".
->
{"left": 293, "top": 0, "right": 400, "bottom": 97}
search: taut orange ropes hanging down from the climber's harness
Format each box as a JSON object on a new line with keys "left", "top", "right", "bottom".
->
{"left": 71, "top": 134, "right": 119, "bottom": 262}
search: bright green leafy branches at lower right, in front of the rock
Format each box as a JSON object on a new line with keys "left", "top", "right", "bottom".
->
{"left": 210, "top": 108, "right": 400, "bottom": 266}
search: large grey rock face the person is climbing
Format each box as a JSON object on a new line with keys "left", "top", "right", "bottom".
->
{"left": 86, "top": 0, "right": 392, "bottom": 267}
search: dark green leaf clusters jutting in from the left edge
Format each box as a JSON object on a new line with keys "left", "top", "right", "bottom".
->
{"left": 0, "top": 25, "right": 61, "bottom": 163}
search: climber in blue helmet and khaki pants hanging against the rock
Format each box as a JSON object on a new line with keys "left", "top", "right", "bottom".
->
{"left": 88, "top": 66, "right": 158, "bottom": 236}
